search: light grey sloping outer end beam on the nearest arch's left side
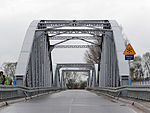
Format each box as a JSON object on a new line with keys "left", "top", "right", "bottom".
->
{"left": 15, "top": 21, "right": 40, "bottom": 86}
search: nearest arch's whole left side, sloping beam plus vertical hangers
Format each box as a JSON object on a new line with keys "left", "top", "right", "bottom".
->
{"left": 15, "top": 21, "right": 52, "bottom": 87}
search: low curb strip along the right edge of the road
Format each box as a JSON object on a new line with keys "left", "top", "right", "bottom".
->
{"left": 91, "top": 90, "right": 150, "bottom": 113}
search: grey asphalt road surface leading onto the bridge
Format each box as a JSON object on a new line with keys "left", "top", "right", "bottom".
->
{"left": 0, "top": 90, "right": 136, "bottom": 113}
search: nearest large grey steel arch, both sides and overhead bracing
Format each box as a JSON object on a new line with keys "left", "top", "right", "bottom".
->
{"left": 15, "top": 20, "right": 129, "bottom": 87}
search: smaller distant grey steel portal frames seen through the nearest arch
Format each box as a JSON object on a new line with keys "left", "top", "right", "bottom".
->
{"left": 54, "top": 63, "right": 96, "bottom": 87}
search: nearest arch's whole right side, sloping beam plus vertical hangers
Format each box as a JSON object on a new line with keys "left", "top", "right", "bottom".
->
{"left": 99, "top": 21, "right": 130, "bottom": 87}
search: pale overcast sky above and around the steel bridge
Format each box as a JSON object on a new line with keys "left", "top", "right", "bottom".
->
{"left": 0, "top": 0, "right": 150, "bottom": 65}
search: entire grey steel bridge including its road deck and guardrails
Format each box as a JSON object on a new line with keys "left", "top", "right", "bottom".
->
{"left": 0, "top": 20, "right": 150, "bottom": 113}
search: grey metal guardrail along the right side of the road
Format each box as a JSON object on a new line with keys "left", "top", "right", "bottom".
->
{"left": 87, "top": 85, "right": 150, "bottom": 101}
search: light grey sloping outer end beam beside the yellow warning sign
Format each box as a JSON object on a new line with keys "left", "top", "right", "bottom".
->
{"left": 109, "top": 20, "right": 130, "bottom": 86}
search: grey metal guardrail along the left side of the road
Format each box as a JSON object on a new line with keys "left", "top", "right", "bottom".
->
{"left": 0, "top": 85, "right": 64, "bottom": 99}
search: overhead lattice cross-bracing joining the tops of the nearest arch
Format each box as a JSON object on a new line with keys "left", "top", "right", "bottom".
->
{"left": 36, "top": 20, "right": 112, "bottom": 48}
